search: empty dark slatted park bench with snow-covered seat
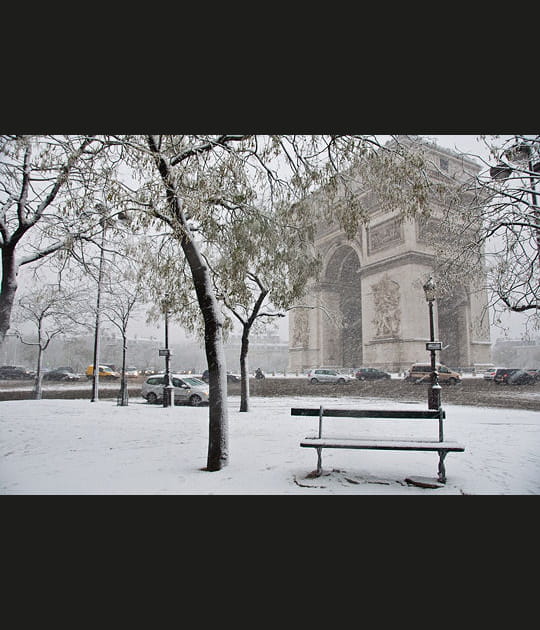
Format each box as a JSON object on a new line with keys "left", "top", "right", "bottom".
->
{"left": 291, "top": 406, "right": 465, "bottom": 483}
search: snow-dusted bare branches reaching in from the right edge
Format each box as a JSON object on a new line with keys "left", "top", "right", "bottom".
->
{"left": 424, "top": 135, "right": 540, "bottom": 338}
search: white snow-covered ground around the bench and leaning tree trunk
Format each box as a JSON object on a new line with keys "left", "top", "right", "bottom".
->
{"left": 0, "top": 396, "right": 540, "bottom": 496}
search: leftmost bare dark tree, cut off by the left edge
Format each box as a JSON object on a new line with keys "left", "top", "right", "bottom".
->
{"left": 0, "top": 135, "right": 117, "bottom": 343}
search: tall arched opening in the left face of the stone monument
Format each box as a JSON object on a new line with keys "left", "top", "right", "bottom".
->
{"left": 321, "top": 245, "right": 363, "bottom": 367}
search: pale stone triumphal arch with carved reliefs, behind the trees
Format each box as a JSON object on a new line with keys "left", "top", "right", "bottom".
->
{"left": 289, "top": 145, "right": 491, "bottom": 371}
